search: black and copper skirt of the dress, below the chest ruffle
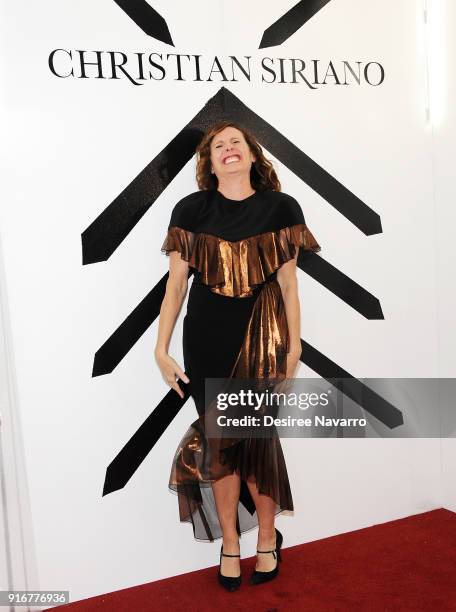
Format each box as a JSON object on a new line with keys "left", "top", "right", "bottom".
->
{"left": 169, "top": 275, "right": 293, "bottom": 541}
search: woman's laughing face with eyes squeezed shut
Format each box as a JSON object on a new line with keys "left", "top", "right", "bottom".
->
{"left": 211, "top": 126, "right": 255, "bottom": 181}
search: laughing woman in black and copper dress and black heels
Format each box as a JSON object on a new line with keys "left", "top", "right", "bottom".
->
{"left": 155, "top": 121, "right": 321, "bottom": 590}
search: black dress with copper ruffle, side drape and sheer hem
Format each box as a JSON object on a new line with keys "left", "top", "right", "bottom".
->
{"left": 161, "top": 189, "right": 321, "bottom": 541}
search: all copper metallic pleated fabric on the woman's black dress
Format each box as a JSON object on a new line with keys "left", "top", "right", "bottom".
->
{"left": 162, "top": 224, "right": 320, "bottom": 541}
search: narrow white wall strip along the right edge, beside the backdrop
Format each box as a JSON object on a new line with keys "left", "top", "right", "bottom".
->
{"left": 429, "top": 0, "right": 456, "bottom": 512}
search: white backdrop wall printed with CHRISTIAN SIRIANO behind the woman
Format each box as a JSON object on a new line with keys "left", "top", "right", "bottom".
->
{"left": 0, "top": 0, "right": 456, "bottom": 600}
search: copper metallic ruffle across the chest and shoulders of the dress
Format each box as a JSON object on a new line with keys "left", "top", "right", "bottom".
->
{"left": 161, "top": 223, "right": 321, "bottom": 297}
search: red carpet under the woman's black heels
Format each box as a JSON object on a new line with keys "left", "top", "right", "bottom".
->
{"left": 53, "top": 508, "right": 456, "bottom": 612}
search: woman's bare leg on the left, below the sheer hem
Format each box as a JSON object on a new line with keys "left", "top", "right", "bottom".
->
{"left": 212, "top": 472, "right": 241, "bottom": 577}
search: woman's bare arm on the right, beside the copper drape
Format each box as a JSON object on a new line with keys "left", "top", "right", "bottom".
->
{"left": 277, "top": 249, "right": 302, "bottom": 378}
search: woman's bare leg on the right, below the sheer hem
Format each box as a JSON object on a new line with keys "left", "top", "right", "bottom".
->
{"left": 247, "top": 479, "right": 276, "bottom": 572}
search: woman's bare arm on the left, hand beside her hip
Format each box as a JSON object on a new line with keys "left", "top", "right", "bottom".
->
{"left": 154, "top": 251, "right": 189, "bottom": 398}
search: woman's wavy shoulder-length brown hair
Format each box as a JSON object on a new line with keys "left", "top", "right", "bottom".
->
{"left": 196, "top": 121, "right": 281, "bottom": 191}
